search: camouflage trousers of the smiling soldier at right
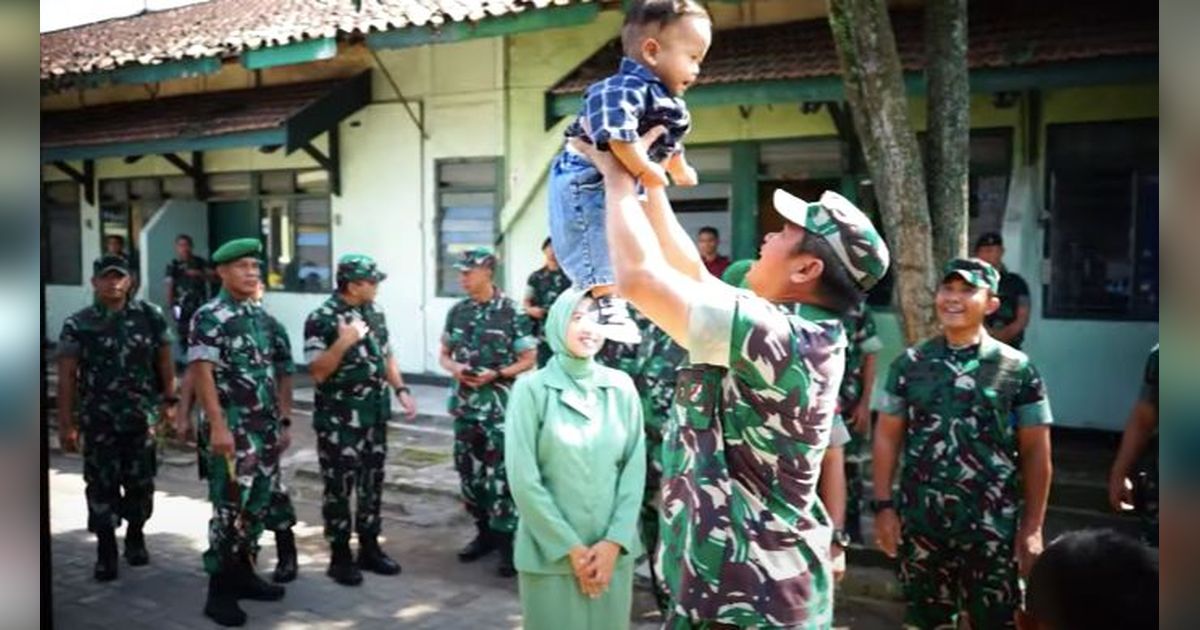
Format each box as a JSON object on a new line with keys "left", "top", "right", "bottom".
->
{"left": 900, "top": 529, "right": 1021, "bottom": 630}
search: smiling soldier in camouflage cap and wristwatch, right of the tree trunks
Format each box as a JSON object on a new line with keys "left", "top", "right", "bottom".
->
{"left": 871, "top": 258, "right": 1051, "bottom": 629}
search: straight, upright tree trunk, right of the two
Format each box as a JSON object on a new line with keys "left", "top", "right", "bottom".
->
{"left": 925, "top": 0, "right": 971, "bottom": 269}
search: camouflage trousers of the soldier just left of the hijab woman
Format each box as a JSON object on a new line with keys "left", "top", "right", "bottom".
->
{"left": 454, "top": 408, "right": 517, "bottom": 534}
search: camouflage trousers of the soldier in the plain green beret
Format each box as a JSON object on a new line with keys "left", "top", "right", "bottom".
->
{"left": 204, "top": 410, "right": 290, "bottom": 574}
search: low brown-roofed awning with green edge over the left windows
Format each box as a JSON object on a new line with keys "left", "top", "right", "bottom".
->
{"left": 42, "top": 71, "right": 371, "bottom": 163}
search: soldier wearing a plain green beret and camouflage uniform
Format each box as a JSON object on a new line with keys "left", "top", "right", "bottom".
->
{"left": 194, "top": 239, "right": 290, "bottom": 626}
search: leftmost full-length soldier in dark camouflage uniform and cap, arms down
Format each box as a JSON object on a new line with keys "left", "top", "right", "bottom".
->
{"left": 58, "top": 254, "right": 175, "bottom": 582}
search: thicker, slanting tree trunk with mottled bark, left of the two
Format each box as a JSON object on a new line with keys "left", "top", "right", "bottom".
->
{"left": 829, "top": 0, "right": 937, "bottom": 344}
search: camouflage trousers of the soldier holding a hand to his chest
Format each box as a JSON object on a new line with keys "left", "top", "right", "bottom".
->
{"left": 313, "top": 410, "right": 388, "bottom": 545}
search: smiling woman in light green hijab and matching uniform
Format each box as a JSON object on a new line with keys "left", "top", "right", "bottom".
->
{"left": 504, "top": 288, "right": 646, "bottom": 630}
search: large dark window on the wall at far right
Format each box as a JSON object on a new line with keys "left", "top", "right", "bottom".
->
{"left": 1045, "top": 120, "right": 1158, "bottom": 320}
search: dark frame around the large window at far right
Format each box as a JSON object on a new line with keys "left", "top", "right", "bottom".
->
{"left": 1038, "top": 118, "right": 1162, "bottom": 322}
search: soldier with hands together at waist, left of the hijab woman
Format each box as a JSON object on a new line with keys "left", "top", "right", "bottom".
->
{"left": 439, "top": 247, "right": 538, "bottom": 577}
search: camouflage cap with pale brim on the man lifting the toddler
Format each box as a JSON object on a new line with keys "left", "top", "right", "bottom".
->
{"left": 774, "top": 188, "right": 890, "bottom": 290}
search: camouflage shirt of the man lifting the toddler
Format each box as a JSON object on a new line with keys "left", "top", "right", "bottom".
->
{"left": 658, "top": 289, "right": 846, "bottom": 628}
